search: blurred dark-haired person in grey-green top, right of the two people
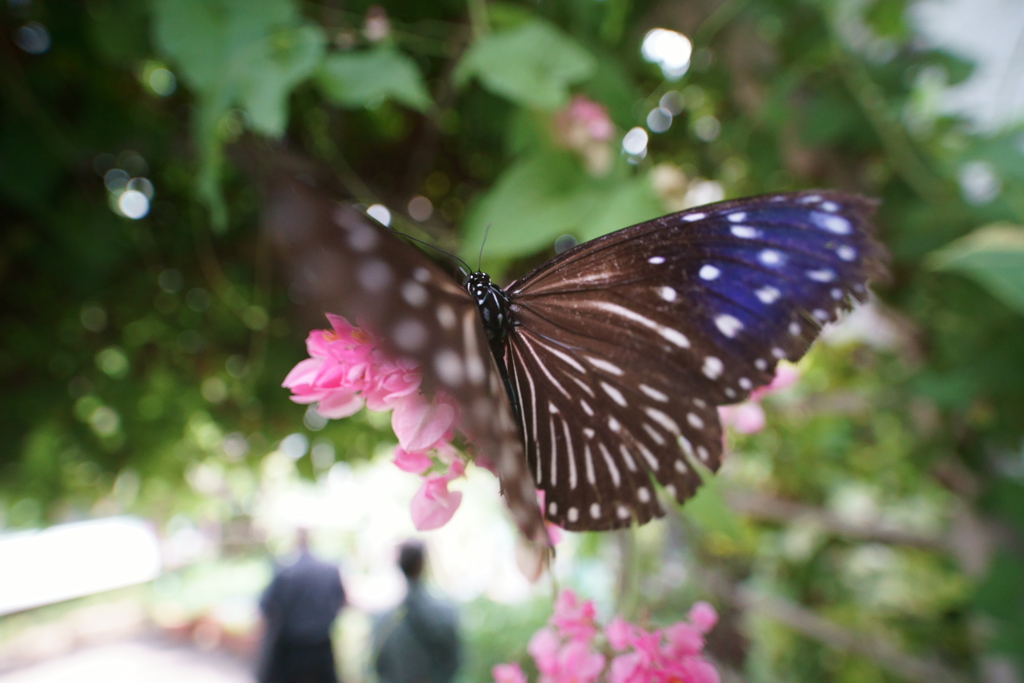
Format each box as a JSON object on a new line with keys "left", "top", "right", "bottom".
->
{"left": 374, "top": 541, "right": 460, "bottom": 683}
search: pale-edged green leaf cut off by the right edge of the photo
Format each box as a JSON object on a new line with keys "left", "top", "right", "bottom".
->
{"left": 927, "top": 224, "right": 1024, "bottom": 313}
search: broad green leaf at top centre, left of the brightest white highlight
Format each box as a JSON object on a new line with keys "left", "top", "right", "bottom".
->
{"left": 455, "top": 19, "right": 596, "bottom": 110}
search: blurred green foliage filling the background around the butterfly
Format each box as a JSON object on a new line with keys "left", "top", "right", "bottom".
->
{"left": 0, "top": 0, "right": 1024, "bottom": 682}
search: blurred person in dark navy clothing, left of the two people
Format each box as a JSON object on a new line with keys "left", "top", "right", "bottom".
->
{"left": 259, "top": 529, "right": 345, "bottom": 683}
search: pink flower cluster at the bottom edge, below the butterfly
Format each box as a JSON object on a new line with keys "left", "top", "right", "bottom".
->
{"left": 490, "top": 590, "right": 719, "bottom": 683}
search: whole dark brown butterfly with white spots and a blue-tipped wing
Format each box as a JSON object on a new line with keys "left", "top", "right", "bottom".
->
{"left": 266, "top": 181, "right": 882, "bottom": 543}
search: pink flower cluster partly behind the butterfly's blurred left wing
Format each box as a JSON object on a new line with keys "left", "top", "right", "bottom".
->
{"left": 282, "top": 313, "right": 466, "bottom": 530}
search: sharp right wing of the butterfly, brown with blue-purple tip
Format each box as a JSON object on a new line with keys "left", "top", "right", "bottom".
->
{"left": 506, "top": 191, "right": 882, "bottom": 529}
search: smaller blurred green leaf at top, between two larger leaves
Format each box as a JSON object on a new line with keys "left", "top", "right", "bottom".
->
{"left": 316, "top": 47, "right": 432, "bottom": 112}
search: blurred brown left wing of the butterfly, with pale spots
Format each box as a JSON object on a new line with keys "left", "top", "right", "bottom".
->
{"left": 264, "top": 176, "right": 548, "bottom": 547}
